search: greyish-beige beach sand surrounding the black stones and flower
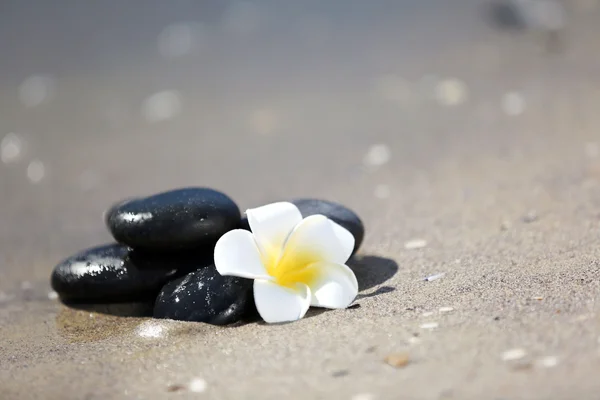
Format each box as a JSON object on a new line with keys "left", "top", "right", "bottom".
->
{"left": 0, "top": 0, "right": 600, "bottom": 400}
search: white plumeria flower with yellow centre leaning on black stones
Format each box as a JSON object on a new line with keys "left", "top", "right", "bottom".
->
{"left": 215, "top": 202, "right": 358, "bottom": 323}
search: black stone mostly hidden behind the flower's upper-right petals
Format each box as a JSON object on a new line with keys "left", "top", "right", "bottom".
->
{"left": 291, "top": 199, "right": 365, "bottom": 253}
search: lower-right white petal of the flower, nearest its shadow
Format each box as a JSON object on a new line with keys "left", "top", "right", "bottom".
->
{"left": 306, "top": 262, "right": 358, "bottom": 308}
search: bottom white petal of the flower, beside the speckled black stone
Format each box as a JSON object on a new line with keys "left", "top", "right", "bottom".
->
{"left": 254, "top": 279, "right": 311, "bottom": 324}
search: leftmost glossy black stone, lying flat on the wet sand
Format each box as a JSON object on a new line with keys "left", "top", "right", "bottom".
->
{"left": 51, "top": 244, "right": 206, "bottom": 302}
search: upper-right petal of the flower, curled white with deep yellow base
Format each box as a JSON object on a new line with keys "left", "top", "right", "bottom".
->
{"left": 272, "top": 215, "right": 352, "bottom": 276}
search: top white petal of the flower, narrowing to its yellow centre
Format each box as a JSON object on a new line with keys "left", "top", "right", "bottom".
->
{"left": 246, "top": 202, "right": 302, "bottom": 265}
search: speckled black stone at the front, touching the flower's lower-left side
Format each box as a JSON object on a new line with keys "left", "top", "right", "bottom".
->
{"left": 154, "top": 266, "right": 254, "bottom": 325}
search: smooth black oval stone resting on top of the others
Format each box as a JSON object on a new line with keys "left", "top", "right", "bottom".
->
{"left": 106, "top": 188, "right": 240, "bottom": 251}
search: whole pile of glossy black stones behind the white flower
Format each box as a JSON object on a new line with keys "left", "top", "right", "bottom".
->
{"left": 51, "top": 188, "right": 364, "bottom": 325}
